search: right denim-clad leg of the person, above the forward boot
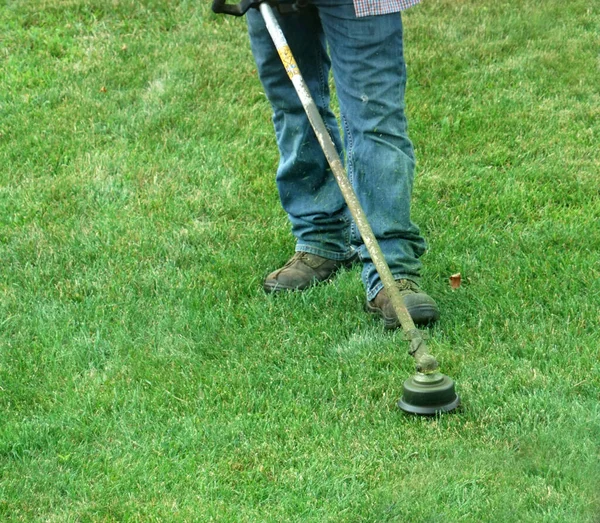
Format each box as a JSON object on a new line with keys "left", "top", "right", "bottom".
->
{"left": 314, "top": 0, "right": 425, "bottom": 300}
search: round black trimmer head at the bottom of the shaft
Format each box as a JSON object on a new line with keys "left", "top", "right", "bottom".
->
{"left": 398, "top": 372, "right": 460, "bottom": 416}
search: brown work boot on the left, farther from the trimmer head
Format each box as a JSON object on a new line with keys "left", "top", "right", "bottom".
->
{"left": 263, "top": 252, "right": 358, "bottom": 293}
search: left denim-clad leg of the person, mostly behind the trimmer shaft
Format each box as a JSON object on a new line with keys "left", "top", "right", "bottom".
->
{"left": 247, "top": 4, "right": 353, "bottom": 260}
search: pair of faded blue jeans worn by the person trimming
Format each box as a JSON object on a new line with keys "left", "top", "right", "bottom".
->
{"left": 247, "top": 0, "right": 425, "bottom": 300}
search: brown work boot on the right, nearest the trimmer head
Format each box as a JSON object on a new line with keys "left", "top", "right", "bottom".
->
{"left": 367, "top": 280, "right": 440, "bottom": 329}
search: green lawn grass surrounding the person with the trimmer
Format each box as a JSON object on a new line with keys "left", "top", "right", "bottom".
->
{"left": 0, "top": 0, "right": 600, "bottom": 522}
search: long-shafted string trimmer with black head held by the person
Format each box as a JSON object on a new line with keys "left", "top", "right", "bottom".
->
{"left": 212, "top": 0, "right": 460, "bottom": 415}
